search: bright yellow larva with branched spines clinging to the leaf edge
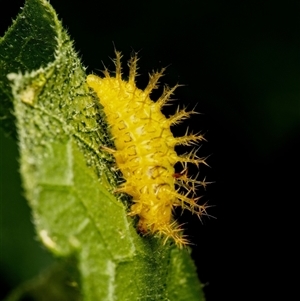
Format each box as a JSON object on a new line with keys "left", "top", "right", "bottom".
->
{"left": 86, "top": 51, "right": 208, "bottom": 248}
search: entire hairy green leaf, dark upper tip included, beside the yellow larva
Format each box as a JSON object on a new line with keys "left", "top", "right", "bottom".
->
{"left": 0, "top": 0, "right": 204, "bottom": 301}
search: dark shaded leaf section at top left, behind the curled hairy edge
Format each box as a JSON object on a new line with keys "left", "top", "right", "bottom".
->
{"left": 0, "top": 0, "right": 58, "bottom": 137}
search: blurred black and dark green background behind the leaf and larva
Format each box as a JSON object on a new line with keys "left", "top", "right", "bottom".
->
{"left": 0, "top": 0, "right": 300, "bottom": 301}
